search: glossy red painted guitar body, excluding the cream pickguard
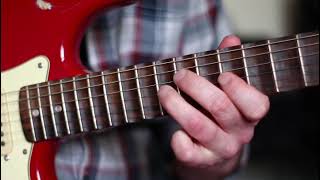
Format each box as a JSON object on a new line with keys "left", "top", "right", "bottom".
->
{"left": 1, "top": 0, "right": 128, "bottom": 180}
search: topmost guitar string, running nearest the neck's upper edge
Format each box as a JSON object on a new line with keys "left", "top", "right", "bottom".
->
{"left": 1, "top": 33, "right": 319, "bottom": 95}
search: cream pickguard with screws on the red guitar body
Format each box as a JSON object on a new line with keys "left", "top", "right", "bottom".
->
{"left": 1, "top": 56, "right": 50, "bottom": 180}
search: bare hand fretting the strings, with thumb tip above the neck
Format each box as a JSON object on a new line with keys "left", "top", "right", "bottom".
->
{"left": 158, "top": 36, "right": 269, "bottom": 178}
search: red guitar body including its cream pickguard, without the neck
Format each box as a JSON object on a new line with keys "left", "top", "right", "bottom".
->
{"left": 1, "top": 0, "right": 132, "bottom": 180}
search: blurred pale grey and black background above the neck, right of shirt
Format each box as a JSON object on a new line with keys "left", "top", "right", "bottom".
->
{"left": 222, "top": 0, "right": 319, "bottom": 40}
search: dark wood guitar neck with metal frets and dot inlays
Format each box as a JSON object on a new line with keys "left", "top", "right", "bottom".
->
{"left": 19, "top": 32, "right": 319, "bottom": 141}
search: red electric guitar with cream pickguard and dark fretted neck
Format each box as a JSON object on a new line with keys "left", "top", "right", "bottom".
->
{"left": 1, "top": 0, "right": 319, "bottom": 180}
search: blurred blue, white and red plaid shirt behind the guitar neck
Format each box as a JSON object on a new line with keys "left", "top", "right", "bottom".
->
{"left": 55, "top": 0, "right": 230, "bottom": 180}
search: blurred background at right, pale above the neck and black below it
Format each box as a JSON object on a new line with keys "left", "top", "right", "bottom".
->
{"left": 223, "top": 0, "right": 320, "bottom": 180}
